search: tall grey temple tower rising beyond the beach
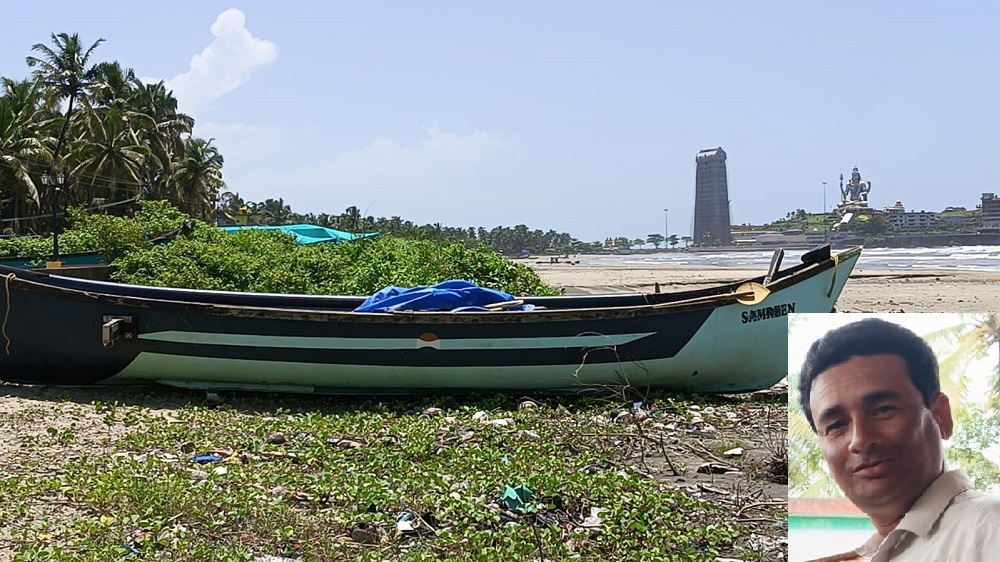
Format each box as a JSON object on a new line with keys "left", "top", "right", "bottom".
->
{"left": 691, "top": 147, "right": 733, "bottom": 246}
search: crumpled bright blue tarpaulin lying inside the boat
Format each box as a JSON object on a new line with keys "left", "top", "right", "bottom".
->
{"left": 354, "top": 279, "right": 514, "bottom": 312}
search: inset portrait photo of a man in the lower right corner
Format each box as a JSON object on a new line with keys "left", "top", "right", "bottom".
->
{"left": 788, "top": 313, "right": 1000, "bottom": 562}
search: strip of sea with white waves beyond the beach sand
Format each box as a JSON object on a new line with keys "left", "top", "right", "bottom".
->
{"left": 574, "top": 246, "right": 1000, "bottom": 272}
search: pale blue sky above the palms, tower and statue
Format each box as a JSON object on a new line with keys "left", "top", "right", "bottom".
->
{"left": 0, "top": 0, "right": 1000, "bottom": 241}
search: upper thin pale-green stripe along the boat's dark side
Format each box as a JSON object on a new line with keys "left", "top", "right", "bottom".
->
{"left": 139, "top": 330, "right": 655, "bottom": 350}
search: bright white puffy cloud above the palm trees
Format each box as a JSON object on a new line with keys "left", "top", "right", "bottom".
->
{"left": 167, "top": 8, "right": 278, "bottom": 114}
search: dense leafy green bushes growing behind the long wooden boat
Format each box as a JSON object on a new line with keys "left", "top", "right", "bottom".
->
{"left": 0, "top": 201, "right": 560, "bottom": 295}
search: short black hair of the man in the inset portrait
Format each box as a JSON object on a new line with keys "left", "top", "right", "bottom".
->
{"left": 799, "top": 318, "right": 941, "bottom": 431}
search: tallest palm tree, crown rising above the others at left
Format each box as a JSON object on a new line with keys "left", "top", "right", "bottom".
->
{"left": 25, "top": 33, "right": 104, "bottom": 171}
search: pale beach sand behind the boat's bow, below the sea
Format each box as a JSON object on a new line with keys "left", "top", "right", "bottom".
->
{"left": 531, "top": 264, "right": 1000, "bottom": 312}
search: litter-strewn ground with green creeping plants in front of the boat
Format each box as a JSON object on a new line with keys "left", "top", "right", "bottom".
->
{"left": 0, "top": 386, "right": 786, "bottom": 562}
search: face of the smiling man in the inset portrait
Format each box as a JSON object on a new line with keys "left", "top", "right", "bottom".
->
{"left": 809, "top": 354, "right": 952, "bottom": 514}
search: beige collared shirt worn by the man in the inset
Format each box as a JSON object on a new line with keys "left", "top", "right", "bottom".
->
{"left": 856, "top": 470, "right": 1000, "bottom": 562}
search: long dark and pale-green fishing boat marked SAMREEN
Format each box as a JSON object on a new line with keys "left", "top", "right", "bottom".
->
{"left": 0, "top": 246, "right": 861, "bottom": 393}
